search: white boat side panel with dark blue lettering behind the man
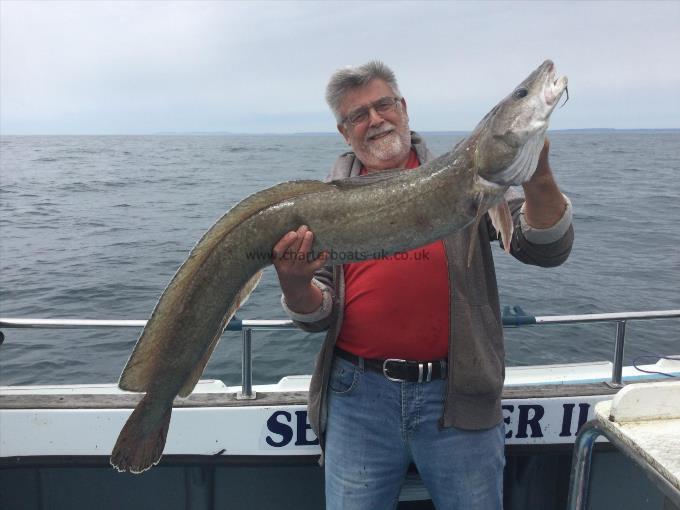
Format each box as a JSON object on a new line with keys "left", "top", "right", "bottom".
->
{"left": 0, "top": 360, "right": 680, "bottom": 460}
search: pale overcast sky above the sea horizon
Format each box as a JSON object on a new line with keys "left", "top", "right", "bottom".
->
{"left": 0, "top": 0, "right": 680, "bottom": 135}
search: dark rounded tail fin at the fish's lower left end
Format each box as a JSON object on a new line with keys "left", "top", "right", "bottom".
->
{"left": 110, "top": 393, "right": 172, "bottom": 473}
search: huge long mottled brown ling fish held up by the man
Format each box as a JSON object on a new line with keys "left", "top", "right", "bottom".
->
{"left": 111, "top": 60, "right": 567, "bottom": 473}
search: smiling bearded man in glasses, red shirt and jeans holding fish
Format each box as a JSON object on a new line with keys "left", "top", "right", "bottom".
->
{"left": 273, "top": 62, "right": 573, "bottom": 510}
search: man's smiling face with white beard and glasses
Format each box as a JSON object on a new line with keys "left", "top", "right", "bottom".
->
{"left": 338, "top": 79, "right": 411, "bottom": 171}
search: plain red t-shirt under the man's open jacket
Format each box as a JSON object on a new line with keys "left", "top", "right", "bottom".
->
{"left": 336, "top": 149, "right": 450, "bottom": 361}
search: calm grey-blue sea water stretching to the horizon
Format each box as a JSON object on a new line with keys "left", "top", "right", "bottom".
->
{"left": 0, "top": 132, "right": 680, "bottom": 385}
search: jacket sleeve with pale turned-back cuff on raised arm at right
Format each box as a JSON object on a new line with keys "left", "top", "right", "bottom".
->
{"left": 487, "top": 196, "right": 574, "bottom": 267}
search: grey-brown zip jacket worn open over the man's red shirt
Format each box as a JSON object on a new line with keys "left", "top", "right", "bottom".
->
{"left": 296, "top": 133, "right": 574, "bottom": 448}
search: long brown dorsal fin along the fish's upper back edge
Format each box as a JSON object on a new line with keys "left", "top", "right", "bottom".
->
{"left": 118, "top": 180, "right": 336, "bottom": 392}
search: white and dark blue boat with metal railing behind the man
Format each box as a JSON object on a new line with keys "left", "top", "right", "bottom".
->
{"left": 0, "top": 307, "right": 680, "bottom": 510}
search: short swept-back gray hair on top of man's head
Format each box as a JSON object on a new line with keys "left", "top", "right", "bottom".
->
{"left": 326, "top": 60, "right": 401, "bottom": 122}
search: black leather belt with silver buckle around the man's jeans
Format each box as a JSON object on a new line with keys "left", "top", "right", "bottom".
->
{"left": 335, "top": 347, "right": 446, "bottom": 382}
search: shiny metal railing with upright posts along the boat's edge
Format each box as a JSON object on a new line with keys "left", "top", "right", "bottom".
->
{"left": 0, "top": 306, "right": 680, "bottom": 399}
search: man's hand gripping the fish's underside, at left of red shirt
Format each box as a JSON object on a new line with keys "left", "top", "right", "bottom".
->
{"left": 272, "top": 225, "right": 327, "bottom": 313}
